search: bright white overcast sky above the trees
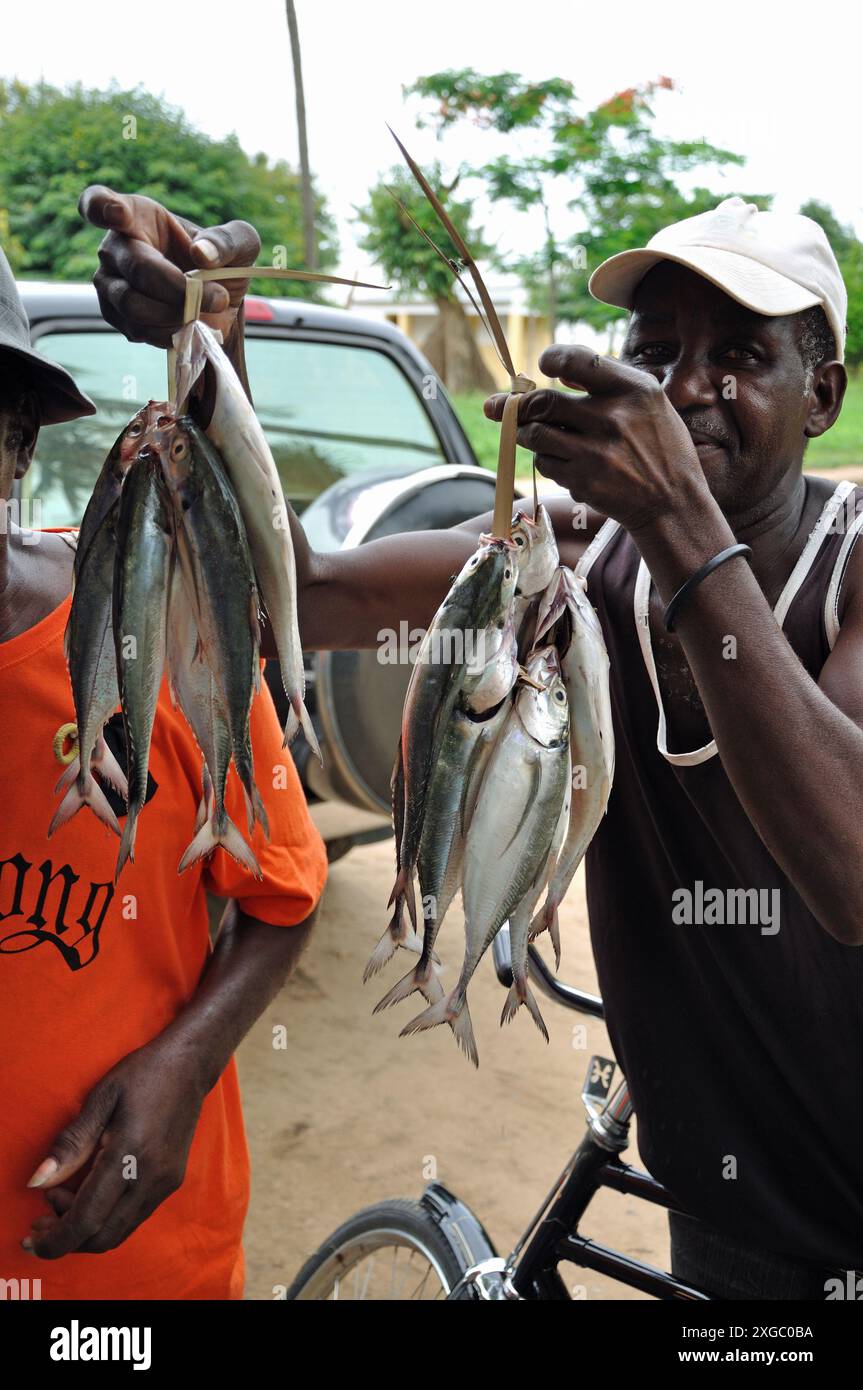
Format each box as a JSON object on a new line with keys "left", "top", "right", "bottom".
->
{"left": 8, "top": 0, "right": 863, "bottom": 274}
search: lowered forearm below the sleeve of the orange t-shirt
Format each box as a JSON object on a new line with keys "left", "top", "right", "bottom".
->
{"left": 158, "top": 902, "right": 317, "bottom": 1095}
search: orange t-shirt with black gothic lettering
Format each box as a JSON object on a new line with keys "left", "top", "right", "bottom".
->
{"left": 0, "top": 581, "right": 327, "bottom": 1298}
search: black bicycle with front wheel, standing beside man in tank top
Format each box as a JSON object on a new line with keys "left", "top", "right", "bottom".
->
{"left": 285, "top": 924, "right": 713, "bottom": 1302}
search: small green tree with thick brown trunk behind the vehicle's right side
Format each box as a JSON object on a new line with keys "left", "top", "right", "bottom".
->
{"left": 356, "top": 164, "right": 495, "bottom": 393}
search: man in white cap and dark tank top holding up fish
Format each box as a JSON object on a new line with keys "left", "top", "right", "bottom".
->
{"left": 89, "top": 197, "right": 863, "bottom": 1298}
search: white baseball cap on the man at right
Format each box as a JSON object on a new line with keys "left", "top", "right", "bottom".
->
{"left": 588, "top": 197, "right": 848, "bottom": 361}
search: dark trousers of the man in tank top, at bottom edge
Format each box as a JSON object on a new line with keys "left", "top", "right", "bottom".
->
{"left": 668, "top": 1212, "right": 844, "bottom": 1302}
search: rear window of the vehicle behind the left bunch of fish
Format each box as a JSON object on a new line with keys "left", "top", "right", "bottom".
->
{"left": 22, "top": 329, "right": 446, "bottom": 527}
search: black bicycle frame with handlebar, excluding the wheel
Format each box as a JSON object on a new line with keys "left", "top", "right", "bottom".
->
{"left": 449, "top": 924, "right": 713, "bottom": 1301}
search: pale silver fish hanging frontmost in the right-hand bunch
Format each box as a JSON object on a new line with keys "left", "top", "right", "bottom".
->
{"left": 402, "top": 648, "right": 570, "bottom": 1065}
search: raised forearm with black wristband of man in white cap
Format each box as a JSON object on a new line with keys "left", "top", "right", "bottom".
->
{"left": 635, "top": 503, "right": 863, "bottom": 944}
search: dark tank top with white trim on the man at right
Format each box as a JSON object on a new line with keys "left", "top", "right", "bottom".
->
{"left": 578, "top": 484, "right": 863, "bottom": 1272}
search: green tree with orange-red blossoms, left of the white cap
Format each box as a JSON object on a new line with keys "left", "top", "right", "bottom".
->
{"left": 406, "top": 68, "right": 766, "bottom": 343}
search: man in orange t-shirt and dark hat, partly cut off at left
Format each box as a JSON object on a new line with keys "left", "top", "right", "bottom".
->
{"left": 0, "top": 208, "right": 327, "bottom": 1300}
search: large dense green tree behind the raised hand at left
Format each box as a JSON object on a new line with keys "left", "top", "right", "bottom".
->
{"left": 0, "top": 82, "right": 336, "bottom": 297}
